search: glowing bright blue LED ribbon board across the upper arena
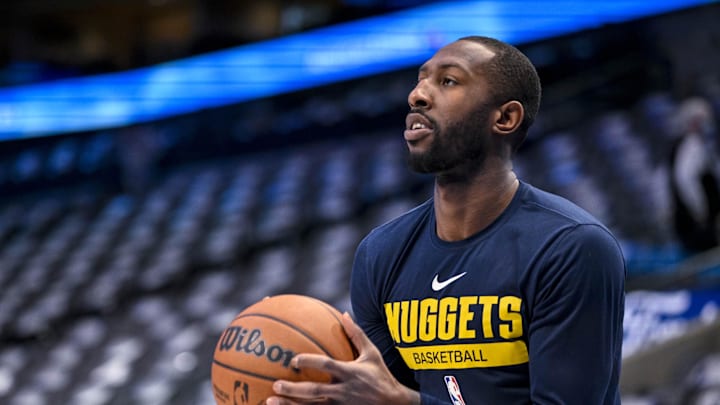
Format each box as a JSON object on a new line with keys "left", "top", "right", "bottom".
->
{"left": 0, "top": 0, "right": 708, "bottom": 140}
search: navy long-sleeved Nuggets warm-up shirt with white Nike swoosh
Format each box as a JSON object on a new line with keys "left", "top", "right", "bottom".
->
{"left": 351, "top": 182, "right": 625, "bottom": 405}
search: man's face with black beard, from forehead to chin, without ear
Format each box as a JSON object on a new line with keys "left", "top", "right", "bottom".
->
{"left": 404, "top": 41, "right": 493, "bottom": 174}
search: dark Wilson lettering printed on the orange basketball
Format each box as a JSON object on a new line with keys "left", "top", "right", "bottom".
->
{"left": 218, "top": 326, "right": 295, "bottom": 368}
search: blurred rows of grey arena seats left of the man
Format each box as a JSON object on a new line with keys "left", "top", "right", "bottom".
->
{"left": 0, "top": 125, "right": 434, "bottom": 404}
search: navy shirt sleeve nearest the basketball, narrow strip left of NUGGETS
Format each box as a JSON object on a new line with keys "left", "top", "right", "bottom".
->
{"left": 350, "top": 240, "right": 419, "bottom": 390}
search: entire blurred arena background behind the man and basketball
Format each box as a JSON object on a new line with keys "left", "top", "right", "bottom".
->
{"left": 0, "top": 0, "right": 720, "bottom": 405}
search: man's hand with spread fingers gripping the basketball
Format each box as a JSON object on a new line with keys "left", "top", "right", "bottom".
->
{"left": 267, "top": 313, "right": 420, "bottom": 405}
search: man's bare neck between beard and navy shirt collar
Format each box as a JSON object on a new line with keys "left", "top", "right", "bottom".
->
{"left": 434, "top": 169, "right": 520, "bottom": 242}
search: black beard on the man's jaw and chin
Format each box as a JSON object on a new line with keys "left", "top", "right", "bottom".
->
{"left": 407, "top": 111, "right": 488, "bottom": 175}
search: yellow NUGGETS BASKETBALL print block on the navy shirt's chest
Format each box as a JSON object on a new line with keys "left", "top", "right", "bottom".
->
{"left": 385, "top": 295, "right": 528, "bottom": 370}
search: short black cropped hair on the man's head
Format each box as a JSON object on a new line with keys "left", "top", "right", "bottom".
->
{"left": 458, "top": 35, "right": 542, "bottom": 150}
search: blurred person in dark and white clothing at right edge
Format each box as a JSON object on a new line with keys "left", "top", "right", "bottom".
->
{"left": 670, "top": 97, "right": 720, "bottom": 253}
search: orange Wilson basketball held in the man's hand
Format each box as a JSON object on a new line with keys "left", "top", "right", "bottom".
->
{"left": 211, "top": 294, "right": 355, "bottom": 405}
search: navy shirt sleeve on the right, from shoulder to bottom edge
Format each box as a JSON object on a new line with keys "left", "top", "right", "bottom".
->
{"left": 528, "top": 225, "right": 625, "bottom": 404}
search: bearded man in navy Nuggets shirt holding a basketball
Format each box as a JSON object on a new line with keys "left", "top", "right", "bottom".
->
{"left": 268, "top": 37, "right": 625, "bottom": 405}
